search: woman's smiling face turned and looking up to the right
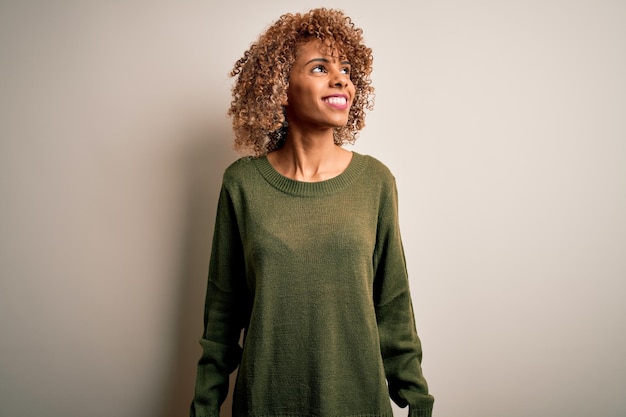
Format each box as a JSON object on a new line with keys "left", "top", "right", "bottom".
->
{"left": 285, "top": 40, "right": 355, "bottom": 129}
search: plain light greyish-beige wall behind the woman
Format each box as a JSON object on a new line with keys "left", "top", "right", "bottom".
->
{"left": 0, "top": 0, "right": 626, "bottom": 417}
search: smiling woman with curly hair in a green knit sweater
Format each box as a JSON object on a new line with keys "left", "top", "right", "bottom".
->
{"left": 191, "top": 9, "right": 433, "bottom": 417}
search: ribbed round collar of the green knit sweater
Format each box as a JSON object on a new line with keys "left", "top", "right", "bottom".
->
{"left": 255, "top": 151, "right": 367, "bottom": 197}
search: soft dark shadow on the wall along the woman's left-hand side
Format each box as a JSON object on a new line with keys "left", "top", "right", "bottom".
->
{"left": 161, "top": 116, "right": 237, "bottom": 417}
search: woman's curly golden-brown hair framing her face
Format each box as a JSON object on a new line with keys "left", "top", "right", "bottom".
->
{"left": 228, "top": 8, "right": 374, "bottom": 156}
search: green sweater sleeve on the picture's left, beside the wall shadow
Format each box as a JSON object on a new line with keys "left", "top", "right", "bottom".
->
{"left": 190, "top": 186, "right": 247, "bottom": 417}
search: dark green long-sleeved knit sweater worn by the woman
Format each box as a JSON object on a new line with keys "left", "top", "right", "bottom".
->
{"left": 191, "top": 152, "right": 433, "bottom": 417}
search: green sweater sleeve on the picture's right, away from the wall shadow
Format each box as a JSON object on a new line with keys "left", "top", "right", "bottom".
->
{"left": 374, "top": 180, "right": 434, "bottom": 417}
